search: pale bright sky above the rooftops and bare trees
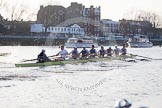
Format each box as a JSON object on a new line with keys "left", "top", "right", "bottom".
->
{"left": 0, "top": 0, "right": 162, "bottom": 21}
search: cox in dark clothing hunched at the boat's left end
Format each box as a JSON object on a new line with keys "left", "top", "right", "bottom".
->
{"left": 37, "top": 49, "right": 51, "bottom": 63}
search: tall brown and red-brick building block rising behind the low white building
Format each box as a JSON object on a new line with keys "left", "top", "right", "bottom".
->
{"left": 37, "top": 2, "right": 101, "bottom": 36}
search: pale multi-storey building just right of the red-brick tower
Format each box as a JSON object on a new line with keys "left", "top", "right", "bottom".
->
{"left": 101, "top": 19, "right": 120, "bottom": 36}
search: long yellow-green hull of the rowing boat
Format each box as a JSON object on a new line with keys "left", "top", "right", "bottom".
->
{"left": 15, "top": 55, "right": 134, "bottom": 67}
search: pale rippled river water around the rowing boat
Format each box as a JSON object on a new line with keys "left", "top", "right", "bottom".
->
{"left": 0, "top": 46, "right": 162, "bottom": 108}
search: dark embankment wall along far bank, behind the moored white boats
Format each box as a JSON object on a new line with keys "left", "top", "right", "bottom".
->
{"left": 0, "top": 35, "right": 162, "bottom": 46}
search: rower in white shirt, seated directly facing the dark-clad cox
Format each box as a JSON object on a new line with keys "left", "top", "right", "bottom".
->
{"left": 55, "top": 46, "right": 68, "bottom": 61}
